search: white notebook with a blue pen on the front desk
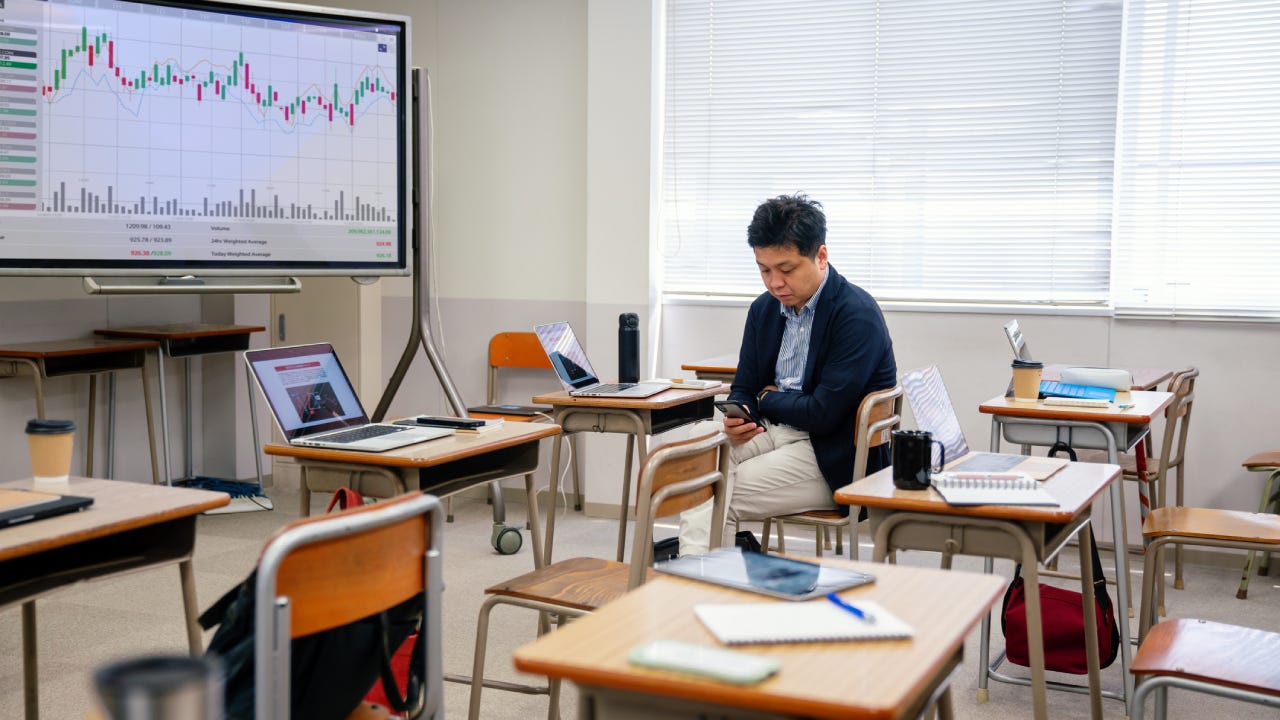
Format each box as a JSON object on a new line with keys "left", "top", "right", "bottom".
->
{"left": 694, "top": 598, "right": 914, "bottom": 644}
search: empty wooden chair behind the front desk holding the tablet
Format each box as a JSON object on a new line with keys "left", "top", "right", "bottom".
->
{"left": 468, "top": 432, "right": 728, "bottom": 720}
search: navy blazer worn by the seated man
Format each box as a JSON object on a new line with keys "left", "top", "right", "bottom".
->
{"left": 728, "top": 265, "right": 897, "bottom": 492}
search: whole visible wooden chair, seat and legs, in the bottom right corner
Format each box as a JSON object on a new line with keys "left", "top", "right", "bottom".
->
{"left": 1129, "top": 620, "right": 1280, "bottom": 720}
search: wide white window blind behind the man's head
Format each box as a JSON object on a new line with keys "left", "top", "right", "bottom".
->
{"left": 660, "top": 0, "right": 1120, "bottom": 304}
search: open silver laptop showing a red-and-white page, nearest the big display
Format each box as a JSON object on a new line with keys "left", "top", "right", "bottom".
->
{"left": 244, "top": 342, "right": 453, "bottom": 452}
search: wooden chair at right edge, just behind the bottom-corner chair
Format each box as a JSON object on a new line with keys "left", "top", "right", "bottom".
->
{"left": 1138, "top": 507, "right": 1280, "bottom": 642}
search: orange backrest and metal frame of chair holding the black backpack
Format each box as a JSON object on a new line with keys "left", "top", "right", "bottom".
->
{"left": 253, "top": 493, "right": 444, "bottom": 719}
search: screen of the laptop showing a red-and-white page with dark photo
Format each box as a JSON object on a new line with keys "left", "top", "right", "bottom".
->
{"left": 246, "top": 343, "right": 369, "bottom": 439}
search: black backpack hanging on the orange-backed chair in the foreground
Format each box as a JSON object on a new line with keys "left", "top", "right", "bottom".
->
{"left": 200, "top": 570, "right": 424, "bottom": 720}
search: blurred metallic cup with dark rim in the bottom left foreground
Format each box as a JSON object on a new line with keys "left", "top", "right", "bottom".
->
{"left": 93, "top": 656, "right": 223, "bottom": 720}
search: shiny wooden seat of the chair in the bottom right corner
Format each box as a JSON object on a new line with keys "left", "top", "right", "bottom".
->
{"left": 1129, "top": 619, "right": 1280, "bottom": 696}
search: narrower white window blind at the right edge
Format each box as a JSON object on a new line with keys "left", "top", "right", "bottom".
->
{"left": 1112, "top": 0, "right": 1280, "bottom": 318}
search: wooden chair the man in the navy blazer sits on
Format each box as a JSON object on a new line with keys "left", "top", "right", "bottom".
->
{"left": 762, "top": 386, "right": 902, "bottom": 560}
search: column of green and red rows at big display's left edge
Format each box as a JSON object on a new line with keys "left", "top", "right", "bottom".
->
{"left": 0, "top": 24, "right": 40, "bottom": 210}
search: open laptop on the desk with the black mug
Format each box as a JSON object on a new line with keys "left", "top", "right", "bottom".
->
{"left": 899, "top": 365, "right": 1069, "bottom": 480}
